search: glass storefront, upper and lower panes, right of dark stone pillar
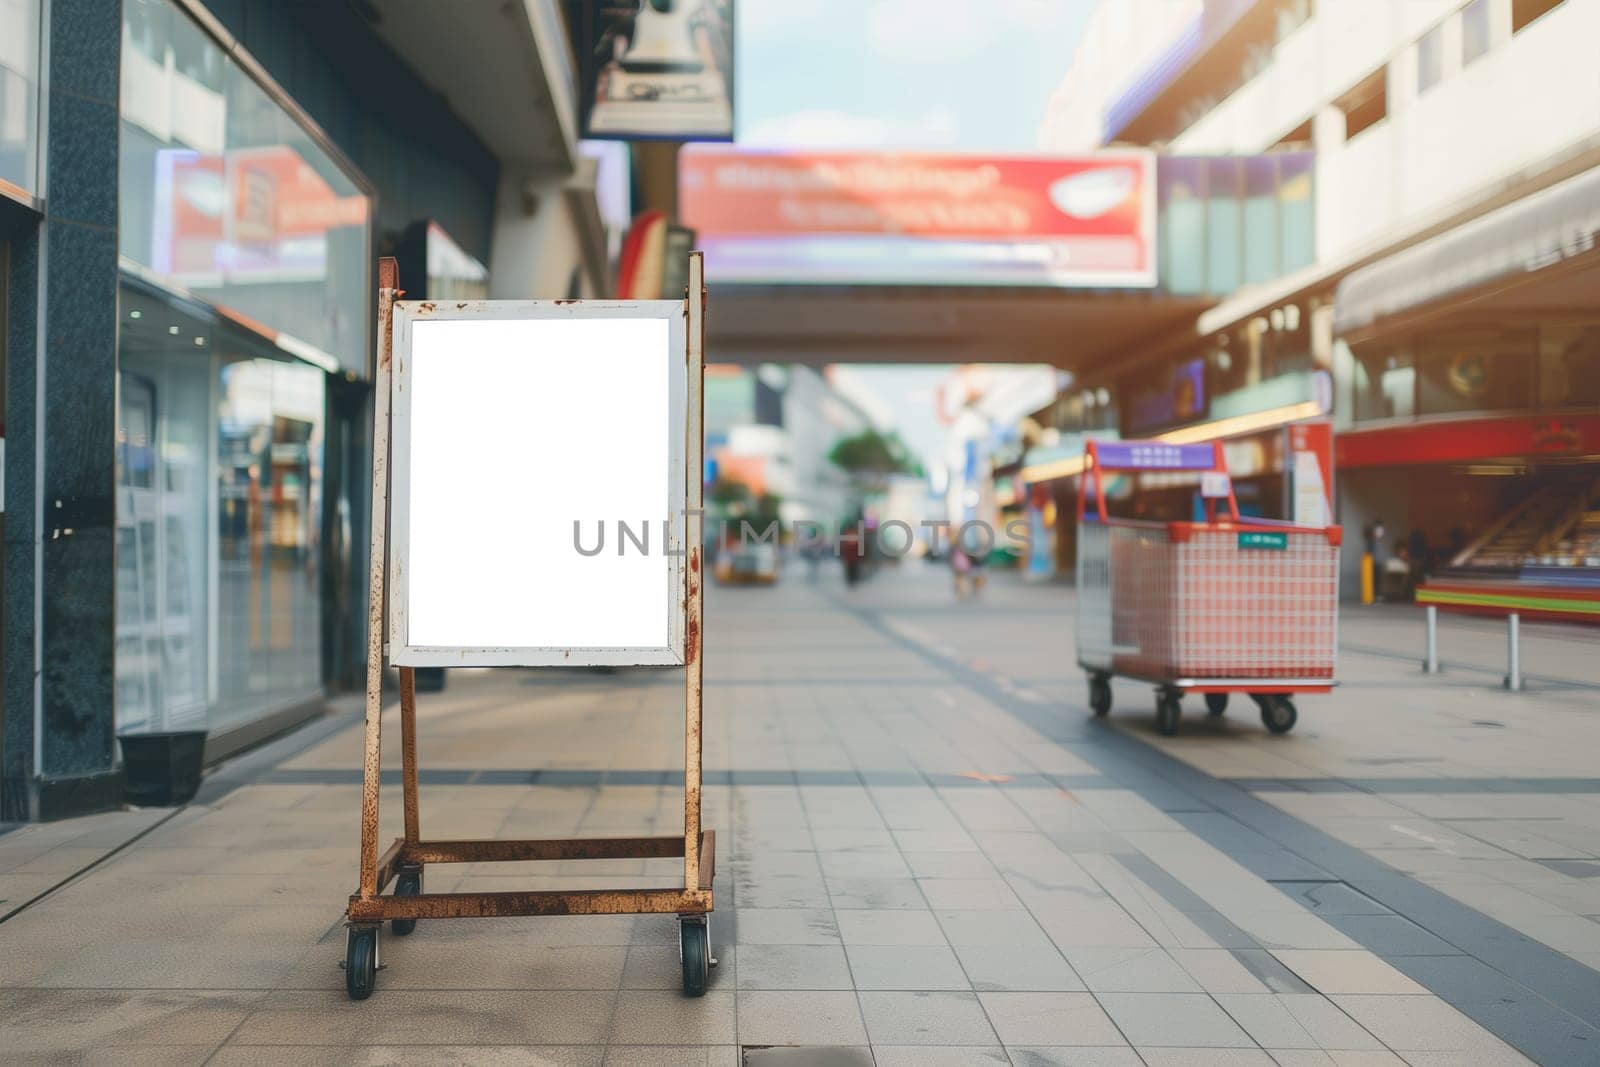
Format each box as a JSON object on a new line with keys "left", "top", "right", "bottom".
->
{"left": 115, "top": 0, "right": 373, "bottom": 758}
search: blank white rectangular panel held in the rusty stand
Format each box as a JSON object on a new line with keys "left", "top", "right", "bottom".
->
{"left": 390, "top": 302, "right": 685, "bottom": 665}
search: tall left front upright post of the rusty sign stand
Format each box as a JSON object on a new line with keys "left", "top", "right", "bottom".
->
{"left": 360, "top": 258, "right": 400, "bottom": 899}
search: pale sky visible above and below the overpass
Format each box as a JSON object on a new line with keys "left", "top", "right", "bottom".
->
{"left": 734, "top": 0, "right": 1094, "bottom": 469}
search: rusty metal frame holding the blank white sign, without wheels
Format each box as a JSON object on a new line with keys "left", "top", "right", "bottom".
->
{"left": 346, "top": 253, "right": 717, "bottom": 926}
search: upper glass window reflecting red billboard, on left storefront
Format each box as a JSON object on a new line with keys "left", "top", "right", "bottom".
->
{"left": 118, "top": 0, "right": 371, "bottom": 376}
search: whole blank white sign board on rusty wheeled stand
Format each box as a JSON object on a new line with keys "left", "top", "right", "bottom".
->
{"left": 344, "top": 253, "right": 715, "bottom": 1000}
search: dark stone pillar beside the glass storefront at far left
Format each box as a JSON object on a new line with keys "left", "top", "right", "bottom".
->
{"left": 30, "top": 0, "right": 122, "bottom": 819}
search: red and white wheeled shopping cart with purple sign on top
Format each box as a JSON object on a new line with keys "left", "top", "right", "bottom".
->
{"left": 1078, "top": 442, "right": 1341, "bottom": 736}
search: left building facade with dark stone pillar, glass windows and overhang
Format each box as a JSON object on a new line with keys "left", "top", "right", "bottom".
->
{"left": 0, "top": 0, "right": 608, "bottom": 821}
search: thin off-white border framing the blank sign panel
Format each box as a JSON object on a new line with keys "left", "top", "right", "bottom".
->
{"left": 387, "top": 301, "right": 702, "bottom": 667}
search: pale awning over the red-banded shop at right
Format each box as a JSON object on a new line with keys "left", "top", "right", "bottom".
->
{"left": 1333, "top": 168, "right": 1600, "bottom": 334}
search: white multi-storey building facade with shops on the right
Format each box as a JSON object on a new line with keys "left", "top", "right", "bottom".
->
{"left": 1036, "top": 0, "right": 1600, "bottom": 595}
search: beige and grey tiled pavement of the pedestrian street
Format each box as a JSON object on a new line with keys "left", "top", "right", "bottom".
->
{"left": 0, "top": 565, "right": 1600, "bottom": 1067}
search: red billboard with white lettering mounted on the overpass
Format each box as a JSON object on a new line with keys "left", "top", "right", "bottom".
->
{"left": 678, "top": 144, "right": 1155, "bottom": 286}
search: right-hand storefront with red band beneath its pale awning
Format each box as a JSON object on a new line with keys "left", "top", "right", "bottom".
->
{"left": 1338, "top": 170, "right": 1600, "bottom": 598}
